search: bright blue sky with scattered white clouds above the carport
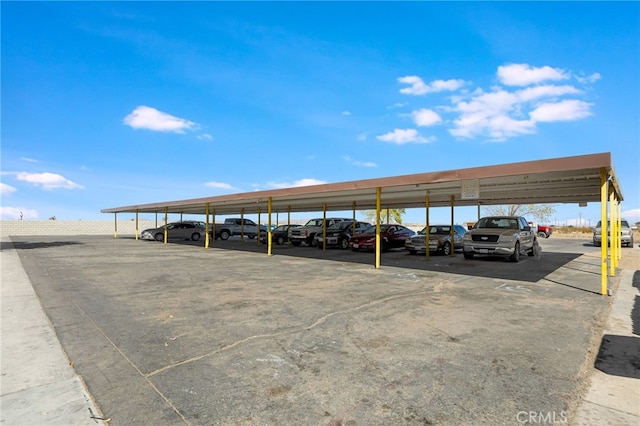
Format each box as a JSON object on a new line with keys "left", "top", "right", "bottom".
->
{"left": 0, "top": 1, "right": 640, "bottom": 225}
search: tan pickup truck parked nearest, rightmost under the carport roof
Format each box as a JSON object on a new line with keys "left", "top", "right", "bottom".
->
{"left": 462, "top": 216, "right": 538, "bottom": 262}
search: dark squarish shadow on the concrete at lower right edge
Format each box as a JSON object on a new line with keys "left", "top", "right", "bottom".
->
{"left": 595, "top": 334, "right": 640, "bottom": 379}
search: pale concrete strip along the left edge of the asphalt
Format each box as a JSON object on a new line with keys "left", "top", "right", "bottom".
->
{"left": 0, "top": 238, "right": 105, "bottom": 425}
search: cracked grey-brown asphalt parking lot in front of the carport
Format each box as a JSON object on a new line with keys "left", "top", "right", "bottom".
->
{"left": 12, "top": 236, "right": 633, "bottom": 425}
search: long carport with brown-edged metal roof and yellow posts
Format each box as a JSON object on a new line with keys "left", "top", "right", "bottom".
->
{"left": 102, "top": 152, "right": 623, "bottom": 295}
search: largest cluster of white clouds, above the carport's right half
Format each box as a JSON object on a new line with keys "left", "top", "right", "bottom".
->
{"left": 388, "top": 64, "right": 600, "bottom": 144}
